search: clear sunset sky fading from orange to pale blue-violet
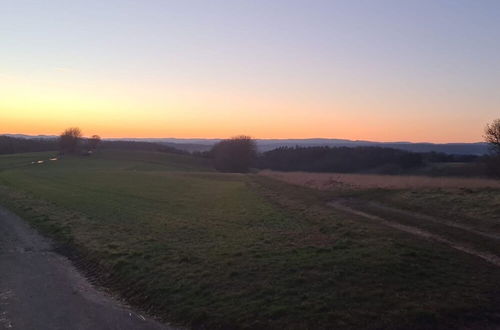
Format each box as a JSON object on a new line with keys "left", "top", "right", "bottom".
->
{"left": 0, "top": 0, "right": 500, "bottom": 142}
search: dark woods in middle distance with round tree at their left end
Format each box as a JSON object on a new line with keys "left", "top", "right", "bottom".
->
{"left": 201, "top": 136, "right": 430, "bottom": 172}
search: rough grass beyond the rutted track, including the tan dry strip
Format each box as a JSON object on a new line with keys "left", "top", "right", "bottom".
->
{"left": 260, "top": 171, "right": 500, "bottom": 240}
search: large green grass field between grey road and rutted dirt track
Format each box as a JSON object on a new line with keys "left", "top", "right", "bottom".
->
{"left": 0, "top": 151, "right": 500, "bottom": 329}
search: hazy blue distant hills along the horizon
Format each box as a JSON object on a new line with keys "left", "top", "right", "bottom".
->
{"left": 0, "top": 134, "right": 488, "bottom": 155}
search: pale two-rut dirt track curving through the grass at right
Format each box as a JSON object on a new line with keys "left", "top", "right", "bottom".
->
{"left": 328, "top": 200, "right": 500, "bottom": 267}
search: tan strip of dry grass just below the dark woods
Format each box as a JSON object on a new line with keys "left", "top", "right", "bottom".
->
{"left": 259, "top": 170, "right": 500, "bottom": 190}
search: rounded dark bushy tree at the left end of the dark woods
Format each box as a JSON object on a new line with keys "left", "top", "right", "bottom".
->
{"left": 210, "top": 135, "right": 257, "bottom": 173}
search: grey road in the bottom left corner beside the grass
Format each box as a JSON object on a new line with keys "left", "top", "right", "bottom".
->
{"left": 0, "top": 207, "right": 173, "bottom": 330}
